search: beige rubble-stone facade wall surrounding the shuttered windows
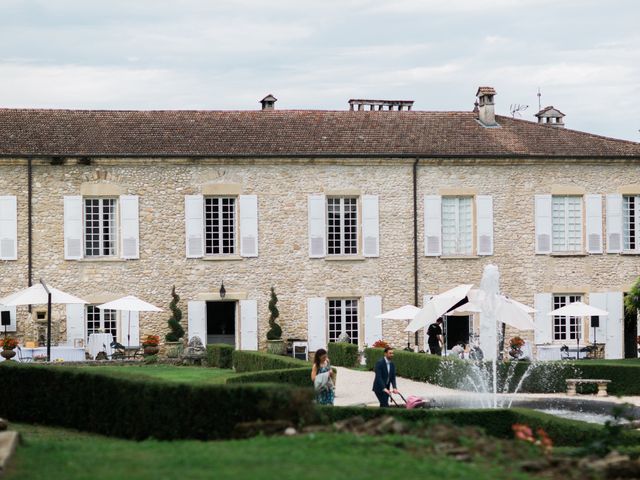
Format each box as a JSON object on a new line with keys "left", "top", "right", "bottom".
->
{"left": 0, "top": 158, "right": 640, "bottom": 356}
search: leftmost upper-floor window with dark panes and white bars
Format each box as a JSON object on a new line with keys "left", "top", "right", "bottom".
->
{"left": 84, "top": 198, "right": 117, "bottom": 257}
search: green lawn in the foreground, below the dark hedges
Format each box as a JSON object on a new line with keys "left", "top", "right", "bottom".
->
{"left": 4, "top": 424, "right": 535, "bottom": 480}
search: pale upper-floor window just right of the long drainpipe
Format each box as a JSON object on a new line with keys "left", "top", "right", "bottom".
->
{"left": 442, "top": 197, "right": 473, "bottom": 255}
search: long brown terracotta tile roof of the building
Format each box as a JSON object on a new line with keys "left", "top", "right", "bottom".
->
{"left": 0, "top": 109, "right": 640, "bottom": 157}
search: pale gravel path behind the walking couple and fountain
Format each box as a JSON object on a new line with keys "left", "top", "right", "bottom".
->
{"left": 335, "top": 367, "right": 640, "bottom": 407}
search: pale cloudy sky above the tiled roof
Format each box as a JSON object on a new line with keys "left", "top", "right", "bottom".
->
{"left": 0, "top": 0, "right": 640, "bottom": 141}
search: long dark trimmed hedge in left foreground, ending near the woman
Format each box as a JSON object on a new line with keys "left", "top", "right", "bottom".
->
{"left": 0, "top": 362, "right": 313, "bottom": 440}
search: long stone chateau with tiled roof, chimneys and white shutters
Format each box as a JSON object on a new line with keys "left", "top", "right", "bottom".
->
{"left": 0, "top": 87, "right": 640, "bottom": 358}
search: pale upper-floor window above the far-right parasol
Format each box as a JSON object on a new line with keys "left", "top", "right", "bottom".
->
{"left": 551, "top": 195, "right": 582, "bottom": 252}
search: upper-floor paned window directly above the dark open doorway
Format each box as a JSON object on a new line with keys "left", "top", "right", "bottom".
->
{"left": 204, "top": 197, "right": 236, "bottom": 255}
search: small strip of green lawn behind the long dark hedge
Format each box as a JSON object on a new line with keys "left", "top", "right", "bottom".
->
{"left": 70, "top": 365, "right": 234, "bottom": 385}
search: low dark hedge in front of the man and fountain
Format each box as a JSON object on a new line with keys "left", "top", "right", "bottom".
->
{"left": 316, "top": 406, "right": 640, "bottom": 446}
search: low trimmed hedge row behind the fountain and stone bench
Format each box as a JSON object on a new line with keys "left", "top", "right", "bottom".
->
{"left": 365, "top": 348, "right": 640, "bottom": 395}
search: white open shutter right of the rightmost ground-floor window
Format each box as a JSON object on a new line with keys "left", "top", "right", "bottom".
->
{"left": 589, "top": 292, "right": 624, "bottom": 359}
